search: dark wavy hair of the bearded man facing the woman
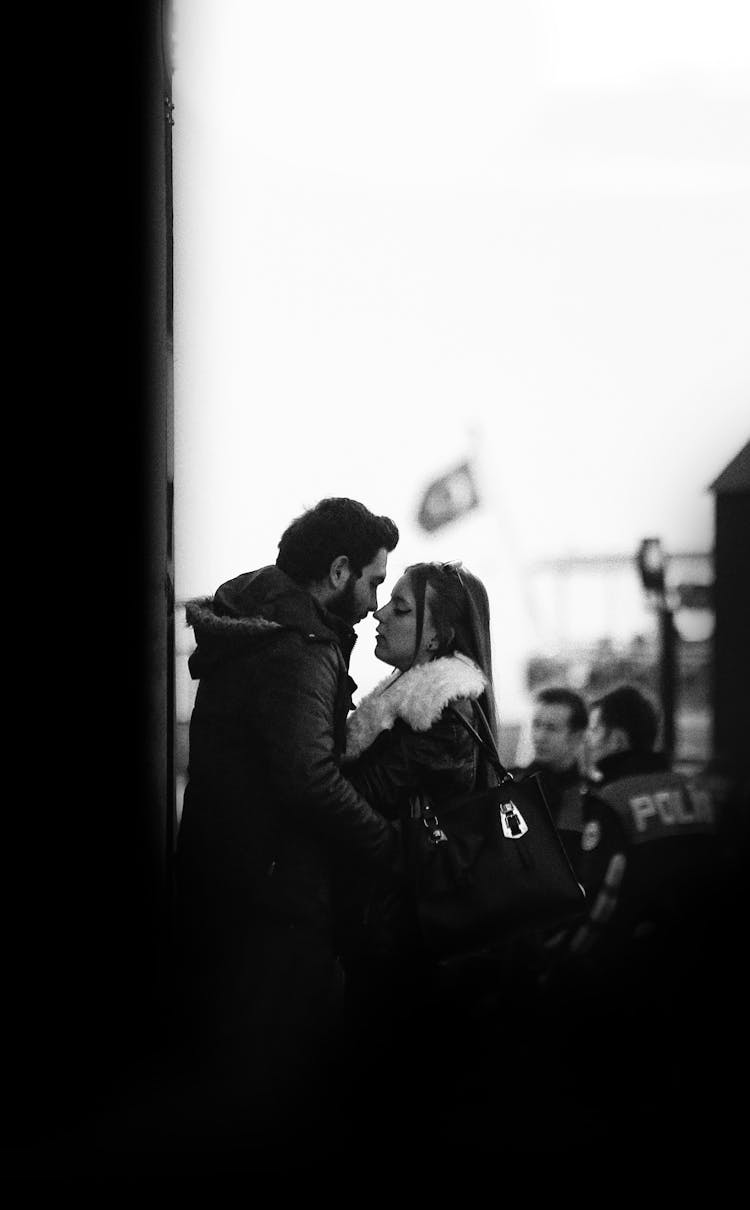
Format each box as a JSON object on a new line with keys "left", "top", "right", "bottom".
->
{"left": 276, "top": 496, "right": 398, "bottom": 584}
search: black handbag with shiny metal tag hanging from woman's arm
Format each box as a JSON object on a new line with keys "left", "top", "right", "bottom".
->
{"left": 404, "top": 703, "right": 585, "bottom": 958}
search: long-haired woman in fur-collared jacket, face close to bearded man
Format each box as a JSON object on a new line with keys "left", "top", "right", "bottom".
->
{"left": 342, "top": 563, "right": 497, "bottom": 1007}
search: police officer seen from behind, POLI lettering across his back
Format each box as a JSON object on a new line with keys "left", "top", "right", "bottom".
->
{"left": 554, "top": 685, "right": 716, "bottom": 966}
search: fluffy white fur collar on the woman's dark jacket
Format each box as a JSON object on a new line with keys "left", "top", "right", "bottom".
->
{"left": 344, "top": 655, "right": 486, "bottom": 760}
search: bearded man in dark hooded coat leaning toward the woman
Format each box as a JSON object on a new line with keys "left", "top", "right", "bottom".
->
{"left": 175, "top": 497, "right": 399, "bottom": 1147}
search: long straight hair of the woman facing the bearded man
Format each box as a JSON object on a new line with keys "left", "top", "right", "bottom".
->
{"left": 406, "top": 563, "right": 497, "bottom": 743}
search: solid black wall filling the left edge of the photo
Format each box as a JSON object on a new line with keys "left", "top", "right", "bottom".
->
{"left": 7, "top": 2, "right": 173, "bottom": 1147}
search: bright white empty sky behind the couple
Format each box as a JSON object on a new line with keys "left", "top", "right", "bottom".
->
{"left": 173, "top": 0, "right": 750, "bottom": 711}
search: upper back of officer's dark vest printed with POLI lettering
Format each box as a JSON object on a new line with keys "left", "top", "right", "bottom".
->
{"left": 594, "top": 772, "right": 716, "bottom": 845}
